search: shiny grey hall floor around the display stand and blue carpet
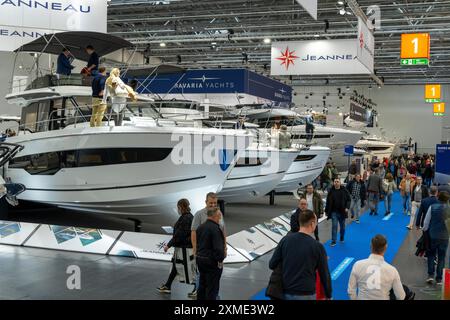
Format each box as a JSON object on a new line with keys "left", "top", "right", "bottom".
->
{"left": 0, "top": 196, "right": 440, "bottom": 300}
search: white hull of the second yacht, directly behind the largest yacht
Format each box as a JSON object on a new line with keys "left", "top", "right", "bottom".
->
{"left": 219, "top": 147, "right": 298, "bottom": 203}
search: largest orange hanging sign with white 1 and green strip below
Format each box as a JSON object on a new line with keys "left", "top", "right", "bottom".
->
{"left": 400, "top": 33, "right": 430, "bottom": 66}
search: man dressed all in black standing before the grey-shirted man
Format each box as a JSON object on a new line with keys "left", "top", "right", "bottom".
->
{"left": 196, "top": 208, "right": 225, "bottom": 300}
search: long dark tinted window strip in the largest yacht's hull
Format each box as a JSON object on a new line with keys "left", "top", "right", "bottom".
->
{"left": 9, "top": 148, "right": 172, "bottom": 175}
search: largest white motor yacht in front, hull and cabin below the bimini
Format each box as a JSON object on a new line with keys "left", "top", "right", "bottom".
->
{"left": 5, "top": 79, "right": 252, "bottom": 215}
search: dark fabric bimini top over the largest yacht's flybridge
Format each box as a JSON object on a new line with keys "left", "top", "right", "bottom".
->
{"left": 14, "top": 31, "right": 133, "bottom": 61}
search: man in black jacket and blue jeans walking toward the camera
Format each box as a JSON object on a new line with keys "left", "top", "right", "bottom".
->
{"left": 325, "top": 178, "right": 351, "bottom": 247}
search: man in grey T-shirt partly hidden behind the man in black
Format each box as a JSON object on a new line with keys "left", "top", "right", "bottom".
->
{"left": 188, "top": 192, "right": 227, "bottom": 298}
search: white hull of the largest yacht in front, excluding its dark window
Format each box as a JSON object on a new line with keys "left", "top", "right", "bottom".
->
{"left": 6, "top": 127, "right": 251, "bottom": 217}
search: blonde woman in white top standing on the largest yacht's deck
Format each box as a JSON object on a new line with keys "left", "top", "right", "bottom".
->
{"left": 103, "top": 68, "right": 136, "bottom": 126}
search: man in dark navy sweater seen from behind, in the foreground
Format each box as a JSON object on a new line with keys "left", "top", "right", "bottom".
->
{"left": 269, "top": 210, "right": 332, "bottom": 300}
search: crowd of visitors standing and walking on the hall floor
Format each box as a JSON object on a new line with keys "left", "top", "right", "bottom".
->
{"left": 158, "top": 151, "right": 450, "bottom": 300}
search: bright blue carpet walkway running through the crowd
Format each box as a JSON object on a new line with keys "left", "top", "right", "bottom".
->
{"left": 251, "top": 192, "right": 410, "bottom": 300}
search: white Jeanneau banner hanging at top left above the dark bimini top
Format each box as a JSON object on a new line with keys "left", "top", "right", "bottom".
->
{"left": 0, "top": 0, "right": 107, "bottom": 51}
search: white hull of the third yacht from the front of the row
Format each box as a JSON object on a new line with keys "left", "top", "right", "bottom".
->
{"left": 275, "top": 146, "right": 330, "bottom": 192}
